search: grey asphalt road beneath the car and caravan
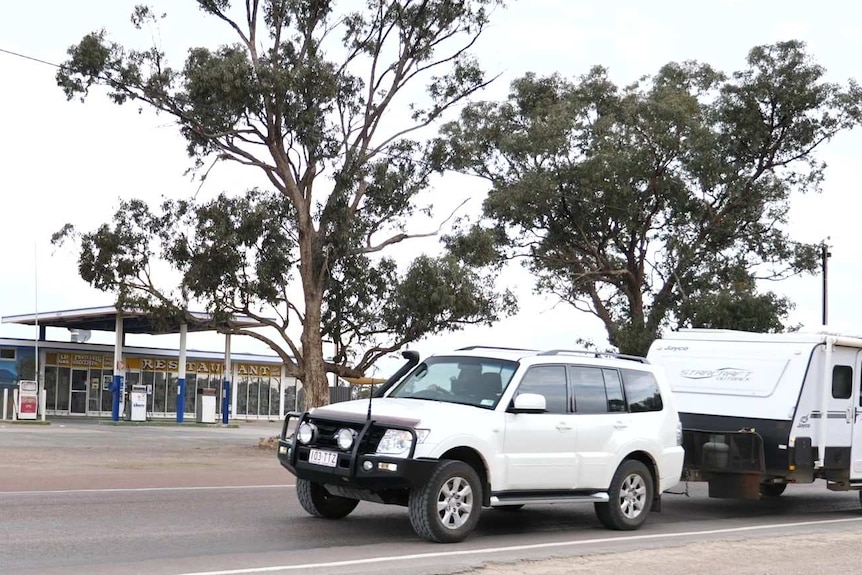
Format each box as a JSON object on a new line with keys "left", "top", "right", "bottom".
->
{"left": 0, "top": 422, "right": 862, "bottom": 575}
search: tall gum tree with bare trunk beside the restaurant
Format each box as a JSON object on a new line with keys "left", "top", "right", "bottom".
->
{"left": 55, "top": 0, "right": 513, "bottom": 405}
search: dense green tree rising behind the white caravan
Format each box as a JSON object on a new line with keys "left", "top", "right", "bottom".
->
{"left": 438, "top": 42, "right": 862, "bottom": 353}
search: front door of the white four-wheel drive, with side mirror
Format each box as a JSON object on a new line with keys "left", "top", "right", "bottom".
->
{"left": 501, "top": 365, "right": 578, "bottom": 490}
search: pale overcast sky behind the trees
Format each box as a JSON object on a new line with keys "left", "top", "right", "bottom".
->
{"left": 0, "top": 0, "right": 862, "bottom": 373}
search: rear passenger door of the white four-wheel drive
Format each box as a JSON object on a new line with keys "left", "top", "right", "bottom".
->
{"left": 568, "top": 365, "right": 631, "bottom": 489}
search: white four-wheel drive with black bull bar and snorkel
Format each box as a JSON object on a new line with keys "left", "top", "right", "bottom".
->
{"left": 278, "top": 347, "right": 683, "bottom": 542}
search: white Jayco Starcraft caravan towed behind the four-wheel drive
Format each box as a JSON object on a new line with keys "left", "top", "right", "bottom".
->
{"left": 647, "top": 329, "right": 862, "bottom": 498}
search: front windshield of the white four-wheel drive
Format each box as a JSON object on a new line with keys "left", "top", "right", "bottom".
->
{"left": 388, "top": 356, "right": 518, "bottom": 409}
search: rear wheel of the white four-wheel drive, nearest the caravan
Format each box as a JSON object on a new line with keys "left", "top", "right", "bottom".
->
{"left": 595, "top": 459, "right": 653, "bottom": 531}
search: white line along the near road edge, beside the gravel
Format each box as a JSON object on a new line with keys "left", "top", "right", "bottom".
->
{"left": 178, "top": 517, "right": 862, "bottom": 575}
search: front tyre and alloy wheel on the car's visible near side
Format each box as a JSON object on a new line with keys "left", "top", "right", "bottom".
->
{"left": 408, "top": 461, "right": 482, "bottom": 543}
